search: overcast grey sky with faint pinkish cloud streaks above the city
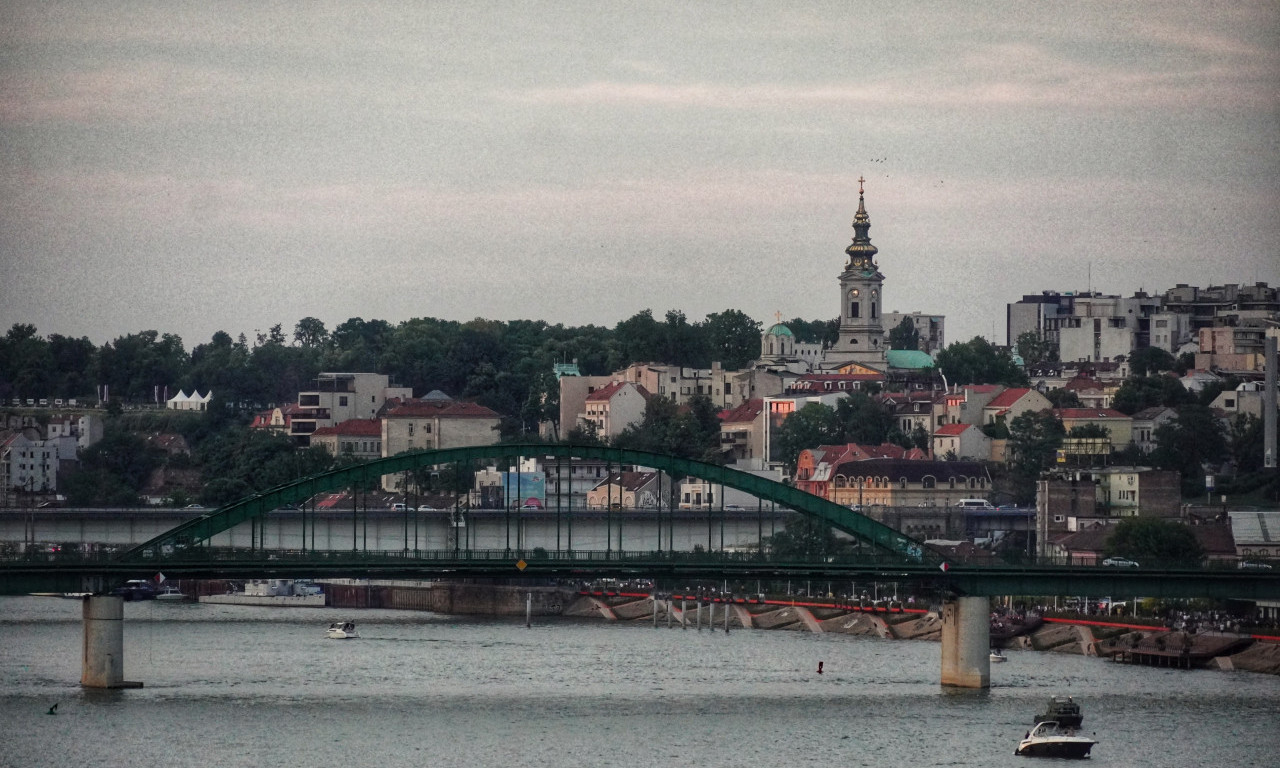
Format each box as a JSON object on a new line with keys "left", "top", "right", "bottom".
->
{"left": 0, "top": 0, "right": 1280, "bottom": 349}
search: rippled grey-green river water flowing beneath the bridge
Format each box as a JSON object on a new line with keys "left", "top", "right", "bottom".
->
{"left": 0, "top": 598, "right": 1280, "bottom": 768}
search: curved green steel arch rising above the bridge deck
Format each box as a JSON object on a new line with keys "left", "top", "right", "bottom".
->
{"left": 119, "top": 443, "right": 942, "bottom": 564}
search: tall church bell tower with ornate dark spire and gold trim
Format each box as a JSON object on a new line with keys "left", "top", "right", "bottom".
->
{"left": 826, "top": 178, "right": 886, "bottom": 370}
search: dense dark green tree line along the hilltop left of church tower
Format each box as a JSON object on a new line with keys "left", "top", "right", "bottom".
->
{"left": 0, "top": 310, "right": 768, "bottom": 430}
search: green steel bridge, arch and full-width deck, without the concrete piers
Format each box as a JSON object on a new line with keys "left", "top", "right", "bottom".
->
{"left": 0, "top": 443, "right": 1280, "bottom": 600}
